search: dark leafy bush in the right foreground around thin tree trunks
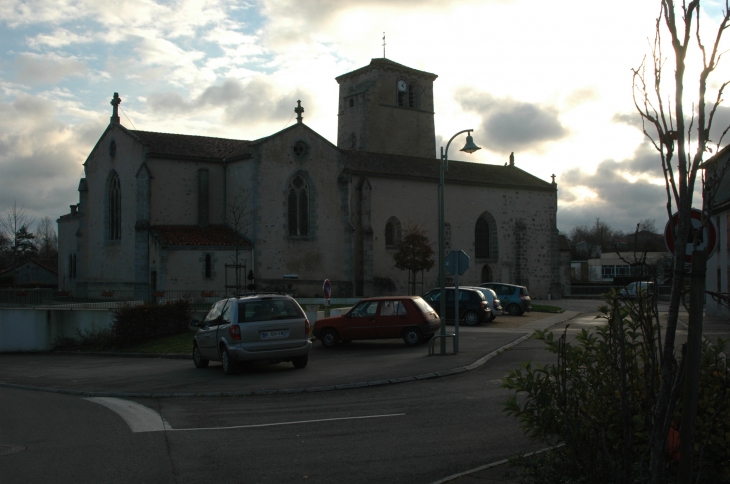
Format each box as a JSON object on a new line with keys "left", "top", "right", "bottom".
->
{"left": 502, "top": 293, "right": 730, "bottom": 483}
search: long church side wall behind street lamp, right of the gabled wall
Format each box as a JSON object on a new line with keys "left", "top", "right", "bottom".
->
{"left": 368, "top": 172, "right": 556, "bottom": 298}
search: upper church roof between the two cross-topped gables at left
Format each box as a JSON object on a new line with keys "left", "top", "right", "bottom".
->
{"left": 128, "top": 129, "right": 250, "bottom": 161}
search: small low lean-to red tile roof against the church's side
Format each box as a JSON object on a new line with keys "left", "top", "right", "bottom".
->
{"left": 150, "top": 225, "right": 251, "bottom": 249}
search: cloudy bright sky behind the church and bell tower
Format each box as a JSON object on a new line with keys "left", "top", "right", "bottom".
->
{"left": 0, "top": 0, "right": 730, "bottom": 233}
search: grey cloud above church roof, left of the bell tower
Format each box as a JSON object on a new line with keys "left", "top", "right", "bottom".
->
{"left": 150, "top": 78, "right": 309, "bottom": 124}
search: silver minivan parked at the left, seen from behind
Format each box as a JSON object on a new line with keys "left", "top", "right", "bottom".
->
{"left": 190, "top": 294, "right": 312, "bottom": 375}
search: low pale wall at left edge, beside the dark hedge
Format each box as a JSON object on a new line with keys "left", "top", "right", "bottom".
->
{"left": 0, "top": 308, "right": 111, "bottom": 353}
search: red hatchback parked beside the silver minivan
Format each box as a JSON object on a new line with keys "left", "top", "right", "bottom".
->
{"left": 314, "top": 296, "right": 441, "bottom": 348}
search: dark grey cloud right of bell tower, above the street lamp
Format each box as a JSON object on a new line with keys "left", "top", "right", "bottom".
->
{"left": 455, "top": 90, "right": 569, "bottom": 151}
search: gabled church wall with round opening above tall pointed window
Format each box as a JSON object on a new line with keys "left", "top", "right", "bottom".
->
{"left": 245, "top": 125, "right": 352, "bottom": 297}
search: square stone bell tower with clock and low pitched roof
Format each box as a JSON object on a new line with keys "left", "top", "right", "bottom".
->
{"left": 335, "top": 58, "right": 438, "bottom": 158}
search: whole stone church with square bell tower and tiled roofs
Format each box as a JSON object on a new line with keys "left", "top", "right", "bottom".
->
{"left": 58, "top": 58, "right": 561, "bottom": 300}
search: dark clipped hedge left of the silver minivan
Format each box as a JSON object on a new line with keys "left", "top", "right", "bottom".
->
{"left": 111, "top": 299, "right": 190, "bottom": 348}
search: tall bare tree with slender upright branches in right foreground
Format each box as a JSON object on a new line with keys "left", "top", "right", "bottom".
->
{"left": 633, "top": 0, "right": 730, "bottom": 484}
